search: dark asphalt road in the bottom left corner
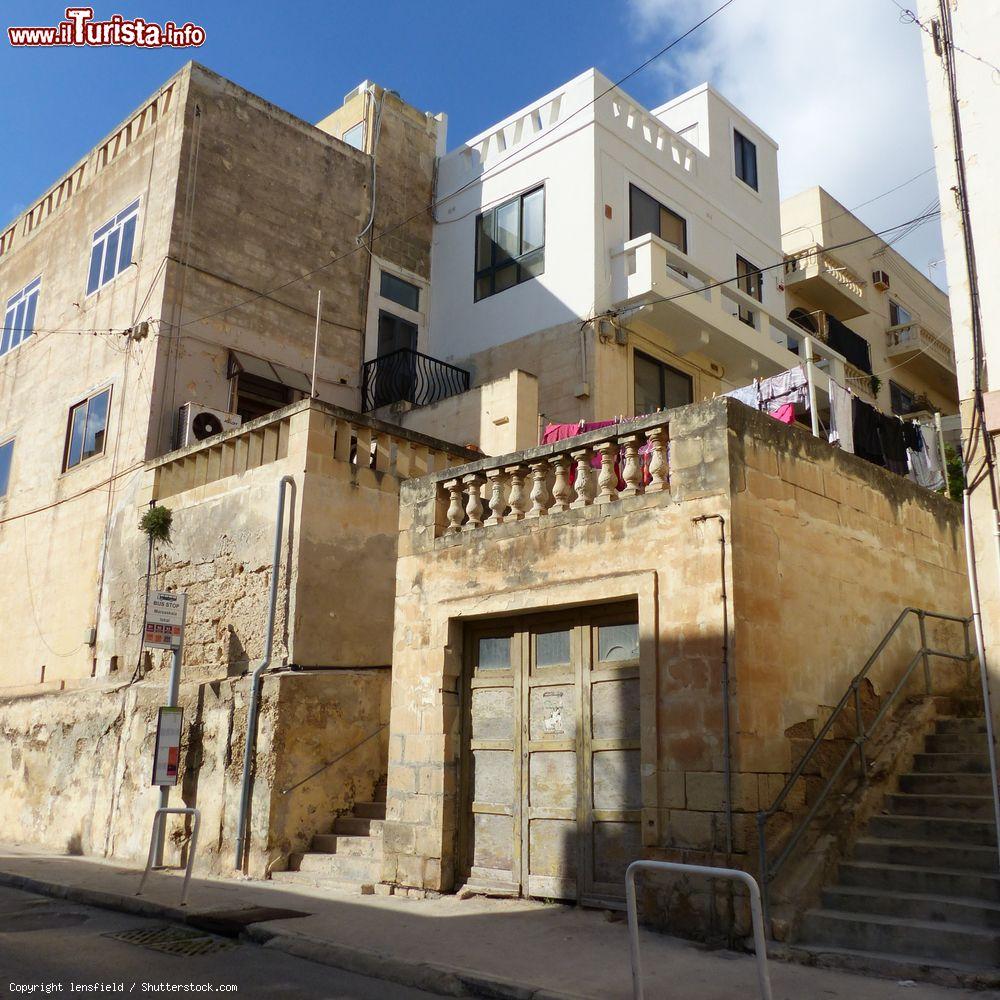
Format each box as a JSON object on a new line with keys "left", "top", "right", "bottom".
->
{"left": 0, "top": 886, "right": 436, "bottom": 1000}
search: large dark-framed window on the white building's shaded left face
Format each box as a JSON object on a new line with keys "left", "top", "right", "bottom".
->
{"left": 475, "top": 188, "right": 545, "bottom": 302}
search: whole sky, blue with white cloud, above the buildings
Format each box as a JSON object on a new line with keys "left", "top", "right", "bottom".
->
{"left": 0, "top": 0, "right": 944, "bottom": 282}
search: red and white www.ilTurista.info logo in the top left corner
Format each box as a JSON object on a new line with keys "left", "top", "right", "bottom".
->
{"left": 7, "top": 7, "right": 205, "bottom": 49}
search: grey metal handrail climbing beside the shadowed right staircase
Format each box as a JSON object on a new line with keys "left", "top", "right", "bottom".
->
{"left": 757, "top": 608, "right": 975, "bottom": 917}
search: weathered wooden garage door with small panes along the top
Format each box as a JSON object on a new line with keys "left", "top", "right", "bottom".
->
{"left": 461, "top": 604, "right": 642, "bottom": 906}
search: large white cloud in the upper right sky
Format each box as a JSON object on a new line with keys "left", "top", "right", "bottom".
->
{"left": 626, "top": 0, "right": 944, "bottom": 281}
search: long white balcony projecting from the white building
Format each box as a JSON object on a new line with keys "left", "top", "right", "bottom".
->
{"left": 612, "top": 234, "right": 844, "bottom": 388}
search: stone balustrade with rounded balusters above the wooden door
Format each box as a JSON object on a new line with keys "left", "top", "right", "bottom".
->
{"left": 437, "top": 414, "right": 670, "bottom": 535}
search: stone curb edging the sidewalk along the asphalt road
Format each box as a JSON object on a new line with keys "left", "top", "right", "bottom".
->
{"left": 0, "top": 871, "right": 584, "bottom": 1000}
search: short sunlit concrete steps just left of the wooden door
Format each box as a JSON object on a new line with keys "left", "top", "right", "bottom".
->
{"left": 271, "top": 782, "right": 386, "bottom": 895}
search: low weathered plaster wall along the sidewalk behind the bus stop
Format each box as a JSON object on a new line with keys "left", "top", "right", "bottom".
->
{"left": 0, "top": 669, "right": 389, "bottom": 876}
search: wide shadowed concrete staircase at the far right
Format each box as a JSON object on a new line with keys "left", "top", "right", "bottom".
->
{"left": 795, "top": 718, "right": 1000, "bottom": 978}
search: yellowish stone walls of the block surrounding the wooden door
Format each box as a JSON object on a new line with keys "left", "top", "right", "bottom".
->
{"left": 385, "top": 399, "right": 967, "bottom": 922}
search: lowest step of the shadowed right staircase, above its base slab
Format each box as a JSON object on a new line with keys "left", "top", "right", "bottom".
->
{"left": 800, "top": 910, "right": 1000, "bottom": 967}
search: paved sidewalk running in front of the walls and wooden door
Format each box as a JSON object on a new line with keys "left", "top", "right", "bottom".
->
{"left": 0, "top": 845, "right": 988, "bottom": 1000}
